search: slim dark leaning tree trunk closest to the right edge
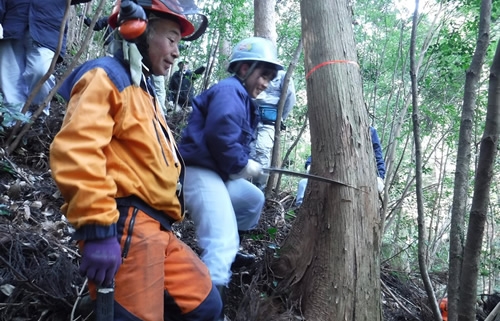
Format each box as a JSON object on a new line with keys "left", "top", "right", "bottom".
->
{"left": 458, "top": 39, "right": 500, "bottom": 321}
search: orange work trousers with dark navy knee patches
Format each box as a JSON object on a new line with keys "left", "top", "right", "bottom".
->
{"left": 89, "top": 202, "right": 222, "bottom": 321}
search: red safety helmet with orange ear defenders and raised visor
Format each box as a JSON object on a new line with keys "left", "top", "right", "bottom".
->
{"left": 108, "top": 0, "right": 204, "bottom": 41}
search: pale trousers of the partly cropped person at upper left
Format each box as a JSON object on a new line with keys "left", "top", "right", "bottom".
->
{"left": 0, "top": 32, "right": 55, "bottom": 113}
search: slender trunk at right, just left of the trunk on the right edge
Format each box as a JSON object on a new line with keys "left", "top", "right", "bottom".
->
{"left": 448, "top": 0, "right": 492, "bottom": 321}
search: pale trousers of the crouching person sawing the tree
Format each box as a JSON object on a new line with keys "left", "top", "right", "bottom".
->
{"left": 184, "top": 166, "right": 265, "bottom": 285}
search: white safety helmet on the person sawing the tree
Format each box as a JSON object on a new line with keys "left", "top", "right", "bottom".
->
{"left": 228, "top": 37, "right": 283, "bottom": 72}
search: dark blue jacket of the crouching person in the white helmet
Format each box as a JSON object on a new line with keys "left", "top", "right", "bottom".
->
{"left": 179, "top": 77, "right": 259, "bottom": 180}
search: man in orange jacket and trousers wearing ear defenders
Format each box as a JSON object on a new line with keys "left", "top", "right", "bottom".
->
{"left": 50, "top": 0, "right": 222, "bottom": 321}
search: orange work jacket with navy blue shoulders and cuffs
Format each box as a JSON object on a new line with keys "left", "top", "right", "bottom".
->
{"left": 50, "top": 57, "right": 184, "bottom": 240}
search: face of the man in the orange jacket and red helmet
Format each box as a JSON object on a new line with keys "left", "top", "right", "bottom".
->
{"left": 148, "top": 19, "right": 181, "bottom": 76}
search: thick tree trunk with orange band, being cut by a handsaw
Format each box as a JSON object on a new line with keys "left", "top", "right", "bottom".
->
{"left": 273, "top": 0, "right": 382, "bottom": 321}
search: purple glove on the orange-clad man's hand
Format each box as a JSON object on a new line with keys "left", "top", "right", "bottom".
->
{"left": 80, "top": 237, "right": 122, "bottom": 286}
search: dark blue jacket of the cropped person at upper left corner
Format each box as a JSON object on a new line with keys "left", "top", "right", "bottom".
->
{"left": 0, "top": 0, "right": 91, "bottom": 59}
